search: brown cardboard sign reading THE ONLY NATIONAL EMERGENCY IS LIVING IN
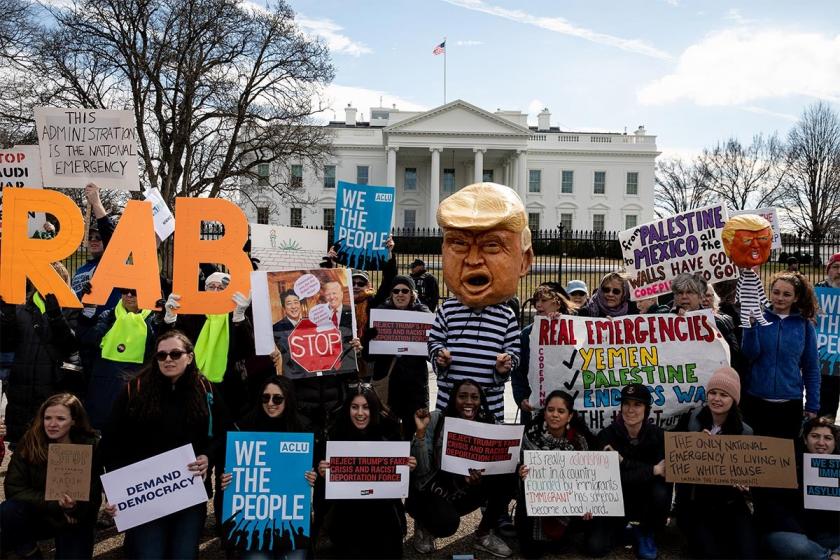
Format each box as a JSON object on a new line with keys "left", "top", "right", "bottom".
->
{"left": 665, "top": 432, "right": 798, "bottom": 488}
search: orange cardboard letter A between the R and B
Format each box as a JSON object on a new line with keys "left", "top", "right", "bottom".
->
{"left": 82, "top": 200, "right": 161, "bottom": 309}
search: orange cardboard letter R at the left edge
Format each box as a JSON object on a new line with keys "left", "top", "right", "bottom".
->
{"left": 0, "top": 188, "right": 85, "bottom": 307}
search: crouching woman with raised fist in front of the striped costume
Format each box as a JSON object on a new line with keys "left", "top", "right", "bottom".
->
{"left": 405, "top": 379, "right": 515, "bottom": 558}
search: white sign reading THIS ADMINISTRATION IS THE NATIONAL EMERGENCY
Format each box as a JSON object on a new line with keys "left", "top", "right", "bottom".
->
{"left": 35, "top": 107, "right": 140, "bottom": 191}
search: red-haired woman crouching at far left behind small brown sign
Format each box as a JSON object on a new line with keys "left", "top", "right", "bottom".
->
{"left": 0, "top": 393, "right": 102, "bottom": 559}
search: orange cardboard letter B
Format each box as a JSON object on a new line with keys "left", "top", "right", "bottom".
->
{"left": 172, "top": 198, "right": 253, "bottom": 315}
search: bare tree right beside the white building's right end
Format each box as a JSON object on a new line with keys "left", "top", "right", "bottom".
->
{"left": 654, "top": 158, "right": 712, "bottom": 218}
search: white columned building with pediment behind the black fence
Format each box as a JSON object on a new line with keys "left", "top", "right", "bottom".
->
{"left": 244, "top": 100, "right": 659, "bottom": 231}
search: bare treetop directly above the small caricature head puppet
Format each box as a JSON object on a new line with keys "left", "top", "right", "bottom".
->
{"left": 699, "top": 134, "right": 786, "bottom": 210}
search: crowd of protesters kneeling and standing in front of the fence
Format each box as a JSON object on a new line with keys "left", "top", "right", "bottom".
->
{"left": 0, "top": 185, "right": 840, "bottom": 560}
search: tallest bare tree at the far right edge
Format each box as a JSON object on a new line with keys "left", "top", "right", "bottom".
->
{"left": 784, "top": 101, "right": 840, "bottom": 256}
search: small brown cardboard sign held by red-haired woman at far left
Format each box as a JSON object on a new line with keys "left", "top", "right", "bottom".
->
{"left": 44, "top": 443, "right": 93, "bottom": 502}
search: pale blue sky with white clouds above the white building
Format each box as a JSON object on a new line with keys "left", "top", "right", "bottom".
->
{"left": 282, "top": 0, "right": 840, "bottom": 157}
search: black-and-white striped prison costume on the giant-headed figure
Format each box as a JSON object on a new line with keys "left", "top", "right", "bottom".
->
{"left": 429, "top": 298, "right": 519, "bottom": 422}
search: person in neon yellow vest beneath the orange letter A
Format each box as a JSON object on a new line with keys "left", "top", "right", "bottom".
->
{"left": 80, "top": 288, "right": 158, "bottom": 430}
